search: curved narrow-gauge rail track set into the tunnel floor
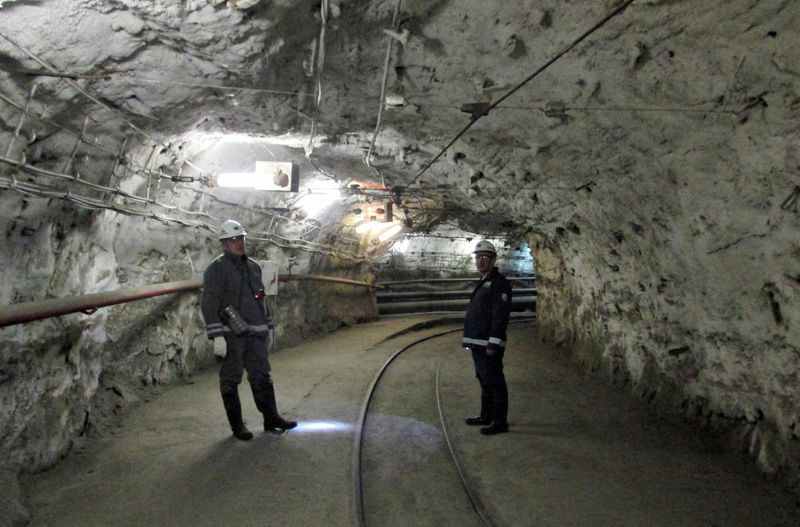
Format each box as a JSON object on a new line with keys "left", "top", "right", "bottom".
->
{"left": 352, "top": 319, "right": 531, "bottom": 527}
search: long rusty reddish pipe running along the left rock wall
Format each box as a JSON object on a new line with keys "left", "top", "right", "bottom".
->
{"left": 0, "top": 274, "right": 375, "bottom": 328}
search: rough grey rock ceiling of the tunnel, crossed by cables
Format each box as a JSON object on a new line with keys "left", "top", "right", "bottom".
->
{"left": 0, "top": 0, "right": 800, "bottom": 242}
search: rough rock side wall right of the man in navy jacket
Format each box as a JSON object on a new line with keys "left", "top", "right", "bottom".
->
{"left": 530, "top": 187, "right": 800, "bottom": 489}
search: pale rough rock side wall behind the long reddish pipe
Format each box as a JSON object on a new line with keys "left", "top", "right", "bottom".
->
{"left": 0, "top": 194, "right": 376, "bottom": 478}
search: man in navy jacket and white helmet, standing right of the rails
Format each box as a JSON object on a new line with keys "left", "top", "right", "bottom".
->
{"left": 462, "top": 240, "right": 511, "bottom": 435}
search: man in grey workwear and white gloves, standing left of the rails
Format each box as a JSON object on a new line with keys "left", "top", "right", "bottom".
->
{"left": 202, "top": 220, "right": 297, "bottom": 441}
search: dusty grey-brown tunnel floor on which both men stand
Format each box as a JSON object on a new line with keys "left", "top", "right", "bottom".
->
{"left": 18, "top": 319, "right": 800, "bottom": 527}
